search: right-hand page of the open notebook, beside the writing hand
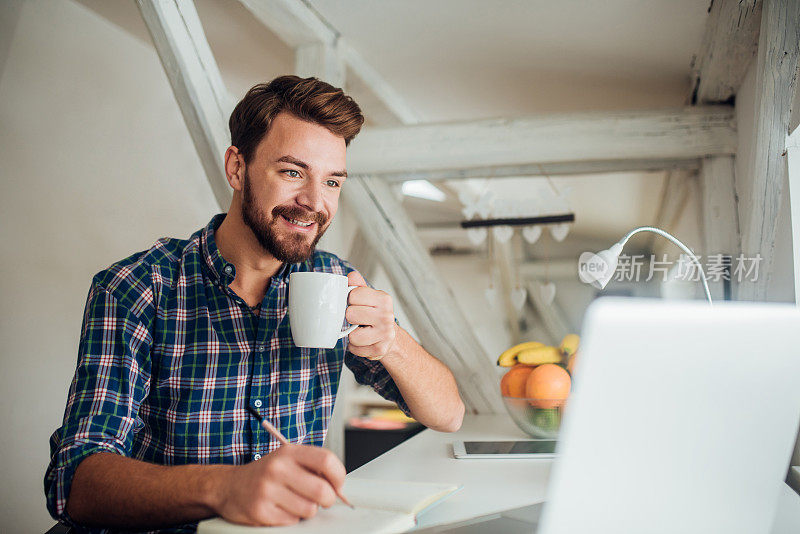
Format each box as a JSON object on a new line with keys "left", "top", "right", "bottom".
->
{"left": 342, "top": 477, "right": 460, "bottom": 516}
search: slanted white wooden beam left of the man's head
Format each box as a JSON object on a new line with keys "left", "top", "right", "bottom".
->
{"left": 137, "top": 0, "right": 233, "bottom": 210}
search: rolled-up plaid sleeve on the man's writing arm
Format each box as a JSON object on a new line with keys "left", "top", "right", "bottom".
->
{"left": 44, "top": 284, "right": 152, "bottom": 524}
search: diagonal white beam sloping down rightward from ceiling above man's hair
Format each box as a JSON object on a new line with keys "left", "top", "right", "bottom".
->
{"left": 239, "top": 0, "right": 420, "bottom": 124}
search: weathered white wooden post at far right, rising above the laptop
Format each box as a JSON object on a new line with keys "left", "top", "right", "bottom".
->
{"left": 737, "top": 0, "right": 800, "bottom": 300}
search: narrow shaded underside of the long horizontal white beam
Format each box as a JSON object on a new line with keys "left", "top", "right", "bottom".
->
{"left": 381, "top": 158, "right": 700, "bottom": 182}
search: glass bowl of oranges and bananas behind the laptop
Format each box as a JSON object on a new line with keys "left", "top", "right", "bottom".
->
{"left": 497, "top": 334, "right": 580, "bottom": 439}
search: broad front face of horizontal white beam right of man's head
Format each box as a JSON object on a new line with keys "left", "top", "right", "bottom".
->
{"left": 348, "top": 106, "right": 736, "bottom": 173}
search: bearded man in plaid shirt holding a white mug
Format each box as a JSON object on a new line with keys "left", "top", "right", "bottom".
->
{"left": 45, "top": 76, "right": 464, "bottom": 531}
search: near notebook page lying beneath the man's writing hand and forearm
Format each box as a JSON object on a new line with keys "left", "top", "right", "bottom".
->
{"left": 197, "top": 504, "right": 416, "bottom": 534}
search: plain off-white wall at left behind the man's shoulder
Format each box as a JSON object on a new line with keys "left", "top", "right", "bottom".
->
{"left": 0, "top": 1, "right": 225, "bottom": 533}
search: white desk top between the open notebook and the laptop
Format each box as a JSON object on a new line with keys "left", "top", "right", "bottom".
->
{"left": 348, "top": 415, "right": 552, "bottom": 527}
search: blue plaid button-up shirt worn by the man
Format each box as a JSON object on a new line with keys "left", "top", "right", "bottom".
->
{"left": 44, "top": 214, "right": 408, "bottom": 532}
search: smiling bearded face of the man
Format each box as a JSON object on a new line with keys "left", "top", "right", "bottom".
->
{"left": 242, "top": 112, "right": 347, "bottom": 263}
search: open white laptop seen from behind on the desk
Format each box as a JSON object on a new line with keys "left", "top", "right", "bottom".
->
{"left": 428, "top": 298, "right": 800, "bottom": 534}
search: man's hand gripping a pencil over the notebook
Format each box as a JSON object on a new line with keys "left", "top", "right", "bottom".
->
{"left": 214, "top": 444, "right": 345, "bottom": 526}
